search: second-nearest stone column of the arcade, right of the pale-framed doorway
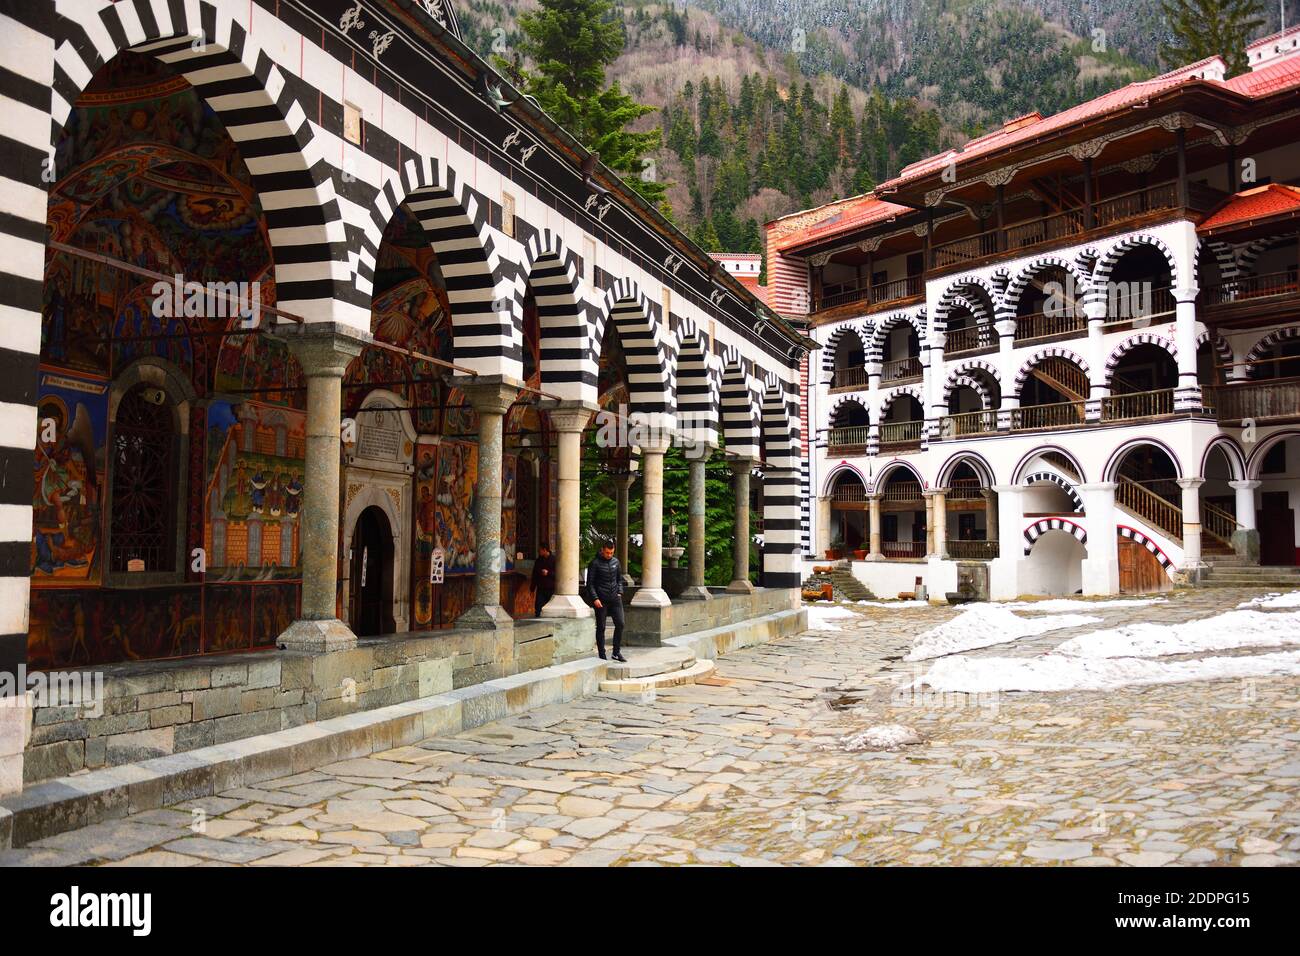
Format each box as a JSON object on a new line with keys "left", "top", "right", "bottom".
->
{"left": 455, "top": 375, "right": 519, "bottom": 631}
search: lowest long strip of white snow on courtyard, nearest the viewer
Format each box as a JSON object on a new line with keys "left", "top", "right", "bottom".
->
{"left": 913, "top": 650, "right": 1300, "bottom": 693}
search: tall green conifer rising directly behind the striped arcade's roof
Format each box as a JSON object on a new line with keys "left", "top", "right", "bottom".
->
{"left": 519, "top": 0, "right": 666, "bottom": 206}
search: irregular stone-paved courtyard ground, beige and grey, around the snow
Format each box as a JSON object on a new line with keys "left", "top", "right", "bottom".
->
{"left": 0, "top": 591, "right": 1300, "bottom": 866}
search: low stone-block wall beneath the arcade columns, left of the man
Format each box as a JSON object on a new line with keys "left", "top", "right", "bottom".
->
{"left": 22, "top": 619, "right": 594, "bottom": 792}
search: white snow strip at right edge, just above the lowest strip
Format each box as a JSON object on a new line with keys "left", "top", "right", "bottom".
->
{"left": 1056, "top": 610, "right": 1300, "bottom": 657}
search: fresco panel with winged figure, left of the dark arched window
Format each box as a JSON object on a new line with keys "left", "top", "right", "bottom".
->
{"left": 31, "top": 371, "right": 108, "bottom": 585}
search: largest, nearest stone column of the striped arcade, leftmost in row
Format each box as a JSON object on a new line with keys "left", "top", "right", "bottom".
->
{"left": 276, "top": 323, "right": 368, "bottom": 652}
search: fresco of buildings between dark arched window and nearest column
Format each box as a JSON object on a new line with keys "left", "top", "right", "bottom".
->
{"left": 204, "top": 402, "right": 307, "bottom": 580}
